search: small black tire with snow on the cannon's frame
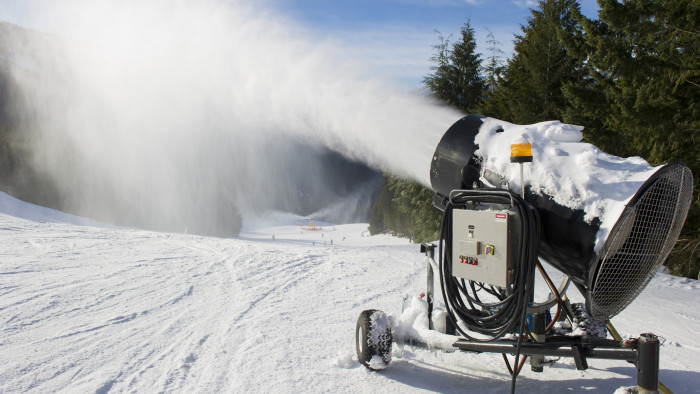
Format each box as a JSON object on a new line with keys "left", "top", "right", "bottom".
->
{"left": 355, "top": 309, "right": 392, "bottom": 370}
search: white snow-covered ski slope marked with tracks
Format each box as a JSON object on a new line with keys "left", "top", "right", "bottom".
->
{"left": 0, "top": 194, "right": 700, "bottom": 393}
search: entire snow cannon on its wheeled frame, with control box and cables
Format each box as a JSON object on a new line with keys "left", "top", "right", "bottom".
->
{"left": 355, "top": 115, "right": 693, "bottom": 393}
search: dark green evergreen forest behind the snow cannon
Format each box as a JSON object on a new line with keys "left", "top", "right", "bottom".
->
{"left": 370, "top": 0, "right": 700, "bottom": 278}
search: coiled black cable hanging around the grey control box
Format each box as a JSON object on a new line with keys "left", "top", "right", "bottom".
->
{"left": 438, "top": 189, "right": 540, "bottom": 392}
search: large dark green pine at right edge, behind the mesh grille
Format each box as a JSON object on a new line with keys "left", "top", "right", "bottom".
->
{"left": 565, "top": 0, "right": 700, "bottom": 277}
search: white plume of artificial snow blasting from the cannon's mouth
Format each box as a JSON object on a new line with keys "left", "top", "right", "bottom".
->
{"left": 10, "top": 0, "right": 461, "bottom": 232}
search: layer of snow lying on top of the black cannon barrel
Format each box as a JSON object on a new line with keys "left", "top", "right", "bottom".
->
{"left": 476, "top": 118, "right": 657, "bottom": 251}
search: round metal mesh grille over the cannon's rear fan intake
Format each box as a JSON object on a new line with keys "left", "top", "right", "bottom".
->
{"left": 590, "top": 164, "right": 693, "bottom": 321}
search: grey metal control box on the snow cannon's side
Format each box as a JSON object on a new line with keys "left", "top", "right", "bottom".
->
{"left": 452, "top": 209, "right": 520, "bottom": 287}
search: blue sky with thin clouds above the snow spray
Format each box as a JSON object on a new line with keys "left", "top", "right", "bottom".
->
{"left": 0, "top": 0, "right": 598, "bottom": 89}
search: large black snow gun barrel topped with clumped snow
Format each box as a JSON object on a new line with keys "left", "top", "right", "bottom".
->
{"left": 430, "top": 115, "right": 693, "bottom": 321}
